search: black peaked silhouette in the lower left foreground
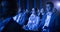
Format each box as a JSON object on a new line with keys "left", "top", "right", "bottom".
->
{"left": 2, "top": 18, "right": 23, "bottom": 32}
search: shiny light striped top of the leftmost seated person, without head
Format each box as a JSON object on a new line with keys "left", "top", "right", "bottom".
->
{"left": 13, "top": 13, "right": 26, "bottom": 25}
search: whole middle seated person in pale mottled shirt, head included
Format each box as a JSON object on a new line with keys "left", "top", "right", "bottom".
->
{"left": 23, "top": 8, "right": 40, "bottom": 31}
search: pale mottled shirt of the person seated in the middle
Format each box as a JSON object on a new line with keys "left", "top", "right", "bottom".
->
{"left": 27, "top": 14, "right": 40, "bottom": 30}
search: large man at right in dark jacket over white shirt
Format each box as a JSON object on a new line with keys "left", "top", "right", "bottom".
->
{"left": 40, "top": 2, "right": 60, "bottom": 32}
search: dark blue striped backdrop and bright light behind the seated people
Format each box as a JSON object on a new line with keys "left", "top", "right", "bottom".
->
{"left": 18, "top": 0, "right": 60, "bottom": 11}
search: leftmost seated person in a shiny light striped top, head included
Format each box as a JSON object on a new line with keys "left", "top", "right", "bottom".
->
{"left": 13, "top": 8, "right": 27, "bottom": 26}
